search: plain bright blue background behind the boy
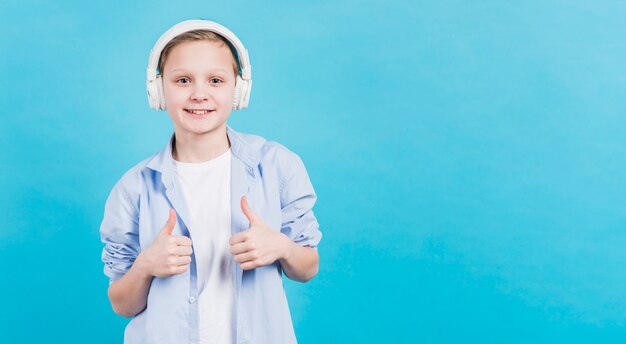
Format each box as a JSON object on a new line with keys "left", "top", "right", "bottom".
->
{"left": 0, "top": 0, "right": 626, "bottom": 343}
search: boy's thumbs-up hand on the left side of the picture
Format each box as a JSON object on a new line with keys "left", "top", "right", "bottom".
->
{"left": 137, "top": 209, "right": 193, "bottom": 278}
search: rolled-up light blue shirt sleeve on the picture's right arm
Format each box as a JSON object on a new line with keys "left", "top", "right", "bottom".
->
{"left": 280, "top": 153, "right": 322, "bottom": 249}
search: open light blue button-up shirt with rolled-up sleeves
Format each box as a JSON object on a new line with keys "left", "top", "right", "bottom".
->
{"left": 100, "top": 127, "right": 322, "bottom": 344}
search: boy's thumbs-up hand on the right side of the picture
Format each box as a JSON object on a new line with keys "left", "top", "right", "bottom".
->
{"left": 230, "top": 196, "right": 292, "bottom": 270}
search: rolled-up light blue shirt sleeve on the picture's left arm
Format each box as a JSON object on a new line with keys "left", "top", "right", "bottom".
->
{"left": 100, "top": 181, "right": 140, "bottom": 282}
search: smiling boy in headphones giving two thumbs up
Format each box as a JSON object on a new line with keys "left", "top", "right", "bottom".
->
{"left": 100, "top": 20, "right": 321, "bottom": 344}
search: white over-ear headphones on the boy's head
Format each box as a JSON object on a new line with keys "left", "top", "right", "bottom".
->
{"left": 146, "top": 20, "right": 252, "bottom": 110}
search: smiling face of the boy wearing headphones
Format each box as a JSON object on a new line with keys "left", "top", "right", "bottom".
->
{"left": 162, "top": 41, "right": 235, "bottom": 137}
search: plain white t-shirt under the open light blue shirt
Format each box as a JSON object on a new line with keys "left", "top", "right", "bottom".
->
{"left": 174, "top": 149, "right": 235, "bottom": 344}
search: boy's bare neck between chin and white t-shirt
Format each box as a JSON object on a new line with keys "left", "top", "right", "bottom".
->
{"left": 172, "top": 126, "right": 230, "bottom": 163}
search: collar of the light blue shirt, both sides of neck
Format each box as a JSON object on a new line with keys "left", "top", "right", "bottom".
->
{"left": 146, "top": 125, "right": 265, "bottom": 174}
